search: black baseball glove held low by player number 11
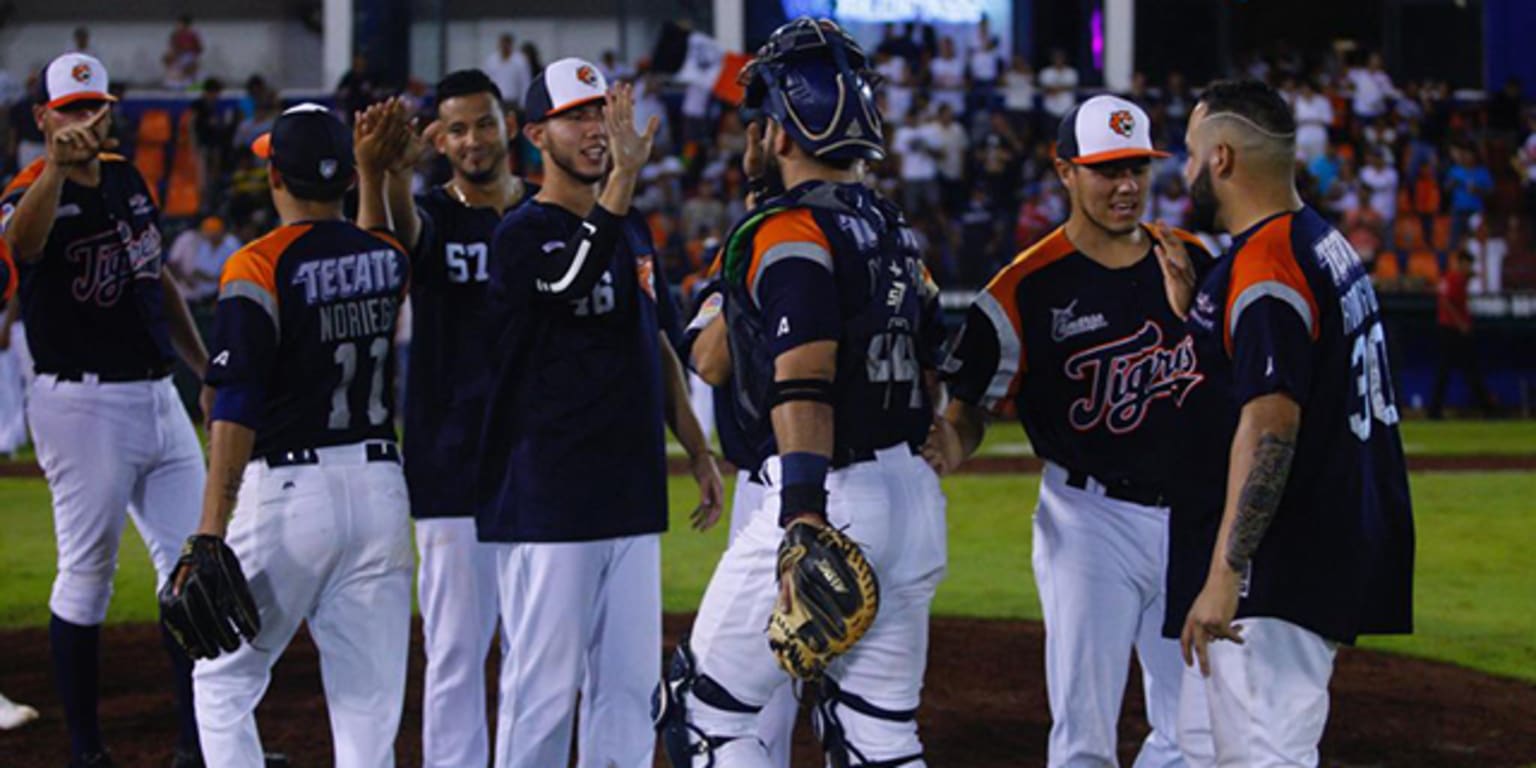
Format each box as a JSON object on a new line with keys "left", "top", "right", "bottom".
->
{"left": 160, "top": 535, "right": 261, "bottom": 660}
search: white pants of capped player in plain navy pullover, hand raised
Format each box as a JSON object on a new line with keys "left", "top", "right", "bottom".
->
{"left": 496, "top": 535, "right": 662, "bottom": 768}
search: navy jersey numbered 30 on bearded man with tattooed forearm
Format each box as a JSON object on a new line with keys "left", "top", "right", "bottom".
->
{"left": 1163, "top": 209, "right": 1413, "bottom": 642}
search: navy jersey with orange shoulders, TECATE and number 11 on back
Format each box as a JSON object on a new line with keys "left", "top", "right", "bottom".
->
{"left": 207, "top": 220, "right": 410, "bottom": 456}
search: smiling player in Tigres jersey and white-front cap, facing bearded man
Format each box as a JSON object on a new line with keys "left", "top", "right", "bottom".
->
{"left": 929, "top": 95, "right": 1210, "bottom": 766}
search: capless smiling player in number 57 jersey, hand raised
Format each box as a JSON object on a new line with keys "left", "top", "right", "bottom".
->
{"left": 358, "top": 69, "right": 530, "bottom": 768}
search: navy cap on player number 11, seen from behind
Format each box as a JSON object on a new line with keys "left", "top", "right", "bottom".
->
{"left": 250, "top": 103, "right": 353, "bottom": 197}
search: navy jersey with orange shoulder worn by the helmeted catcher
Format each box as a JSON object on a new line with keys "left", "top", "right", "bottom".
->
{"left": 723, "top": 183, "right": 943, "bottom": 467}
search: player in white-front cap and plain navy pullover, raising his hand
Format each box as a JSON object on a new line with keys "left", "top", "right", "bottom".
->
{"left": 476, "top": 58, "right": 722, "bottom": 768}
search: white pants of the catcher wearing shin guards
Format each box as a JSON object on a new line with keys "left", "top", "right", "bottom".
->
{"left": 687, "top": 445, "right": 946, "bottom": 768}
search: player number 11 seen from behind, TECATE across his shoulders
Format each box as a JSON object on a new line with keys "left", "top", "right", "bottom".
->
{"left": 183, "top": 104, "right": 413, "bottom": 768}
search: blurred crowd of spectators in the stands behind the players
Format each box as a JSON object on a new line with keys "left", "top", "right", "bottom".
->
{"left": 0, "top": 18, "right": 1536, "bottom": 302}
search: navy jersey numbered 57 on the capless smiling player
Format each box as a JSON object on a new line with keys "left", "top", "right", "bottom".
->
{"left": 404, "top": 187, "right": 525, "bottom": 518}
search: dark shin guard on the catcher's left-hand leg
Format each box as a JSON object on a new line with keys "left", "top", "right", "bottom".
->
{"left": 651, "top": 637, "right": 768, "bottom": 768}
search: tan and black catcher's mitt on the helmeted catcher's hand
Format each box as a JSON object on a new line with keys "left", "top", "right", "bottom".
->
{"left": 768, "top": 518, "right": 880, "bottom": 680}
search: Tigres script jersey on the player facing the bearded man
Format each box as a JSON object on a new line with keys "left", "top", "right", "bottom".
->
{"left": 945, "top": 229, "right": 1210, "bottom": 492}
